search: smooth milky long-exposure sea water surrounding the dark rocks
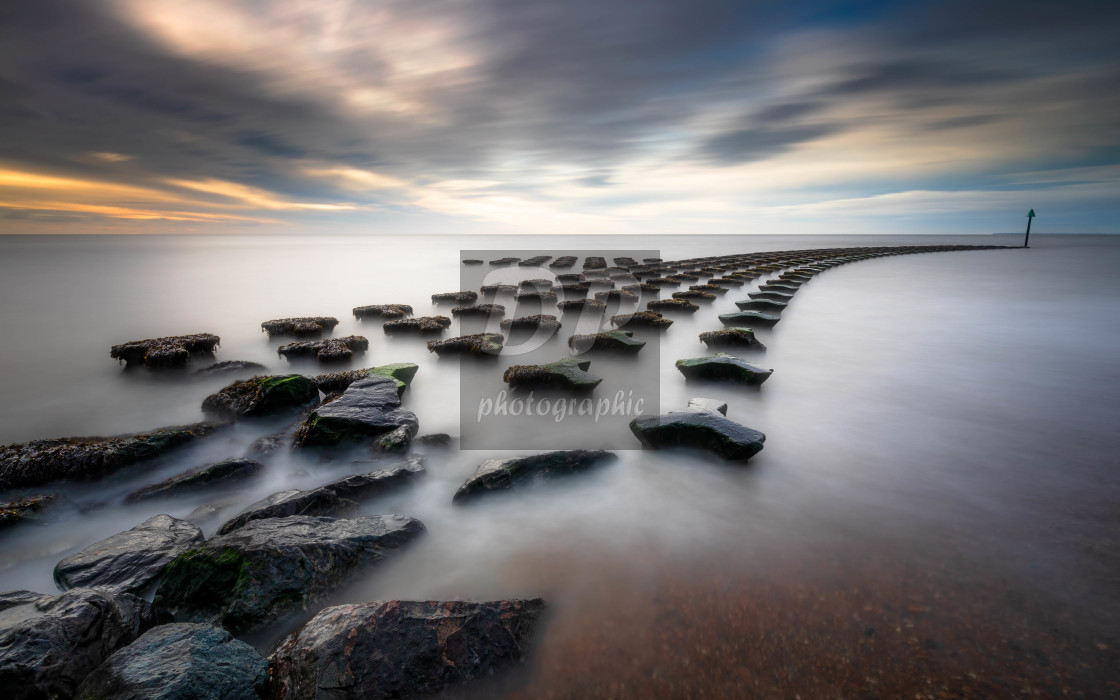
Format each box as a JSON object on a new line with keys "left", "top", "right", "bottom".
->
{"left": 0, "top": 236, "right": 1120, "bottom": 697}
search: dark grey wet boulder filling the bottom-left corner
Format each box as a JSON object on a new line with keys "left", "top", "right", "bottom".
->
{"left": 0, "top": 588, "right": 171, "bottom": 700}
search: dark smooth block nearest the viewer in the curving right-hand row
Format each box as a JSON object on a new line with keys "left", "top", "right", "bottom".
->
{"left": 631, "top": 409, "right": 766, "bottom": 461}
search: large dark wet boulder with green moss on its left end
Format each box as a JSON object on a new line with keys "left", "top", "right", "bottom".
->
{"left": 156, "top": 515, "right": 424, "bottom": 634}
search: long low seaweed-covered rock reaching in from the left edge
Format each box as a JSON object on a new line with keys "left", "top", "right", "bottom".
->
{"left": 0, "top": 423, "right": 220, "bottom": 489}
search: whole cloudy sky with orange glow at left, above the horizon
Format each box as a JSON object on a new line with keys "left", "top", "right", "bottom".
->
{"left": 0, "top": 0, "right": 1120, "bottom": 234}
